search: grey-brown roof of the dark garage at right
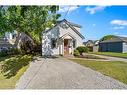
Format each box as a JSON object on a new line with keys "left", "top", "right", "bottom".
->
{"left": 100, "top": 36, "right": 127, "bottom": 43}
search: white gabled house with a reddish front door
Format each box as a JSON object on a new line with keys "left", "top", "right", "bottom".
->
{"left": 42, "top": 19, "right": 84, "bottom": 56}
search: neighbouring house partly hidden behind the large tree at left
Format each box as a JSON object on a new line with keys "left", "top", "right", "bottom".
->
{"left": 0, "top": 31, "right": 33, "bottom": 51}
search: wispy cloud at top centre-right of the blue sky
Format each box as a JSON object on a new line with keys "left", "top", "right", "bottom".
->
{"left": 86, "top": 6, "right": 106, "bottom": 14}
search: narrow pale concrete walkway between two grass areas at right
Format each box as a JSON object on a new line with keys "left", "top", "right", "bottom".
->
{"left": 89, "top": 54, "right": 127, "bottom": 62}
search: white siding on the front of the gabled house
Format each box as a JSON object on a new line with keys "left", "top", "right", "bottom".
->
{"left": 42, "top": 21, "right": 83, "bottom": 55}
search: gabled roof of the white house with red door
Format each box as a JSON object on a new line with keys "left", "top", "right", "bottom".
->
{"left": 45, "top": 19, "right": 85, "bottom": 39}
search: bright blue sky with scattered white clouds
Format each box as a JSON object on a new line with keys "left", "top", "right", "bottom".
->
{"left": 59, "top": 6, "right": 127, "bottom": 41}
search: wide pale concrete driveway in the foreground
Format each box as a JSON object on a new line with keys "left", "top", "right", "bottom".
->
{"left": 16, "top": 58, "right": 127, "bottom": 89}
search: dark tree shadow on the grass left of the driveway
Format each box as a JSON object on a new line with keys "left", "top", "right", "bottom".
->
{"left": 1, "top": 55, "right": 32, "bottom": 78}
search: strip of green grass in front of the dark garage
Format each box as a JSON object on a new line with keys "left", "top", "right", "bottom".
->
{"left": 92, "top": 52, "right": 127, "bottom": 58}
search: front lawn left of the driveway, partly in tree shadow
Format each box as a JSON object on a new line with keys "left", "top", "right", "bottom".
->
{"left": 0, "top": 55, "right": 32, "bottom": 89}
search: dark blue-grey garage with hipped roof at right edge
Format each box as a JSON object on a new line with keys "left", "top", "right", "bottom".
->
{"left": 99, "top": 36, "right": 127, "bottom": 53}
